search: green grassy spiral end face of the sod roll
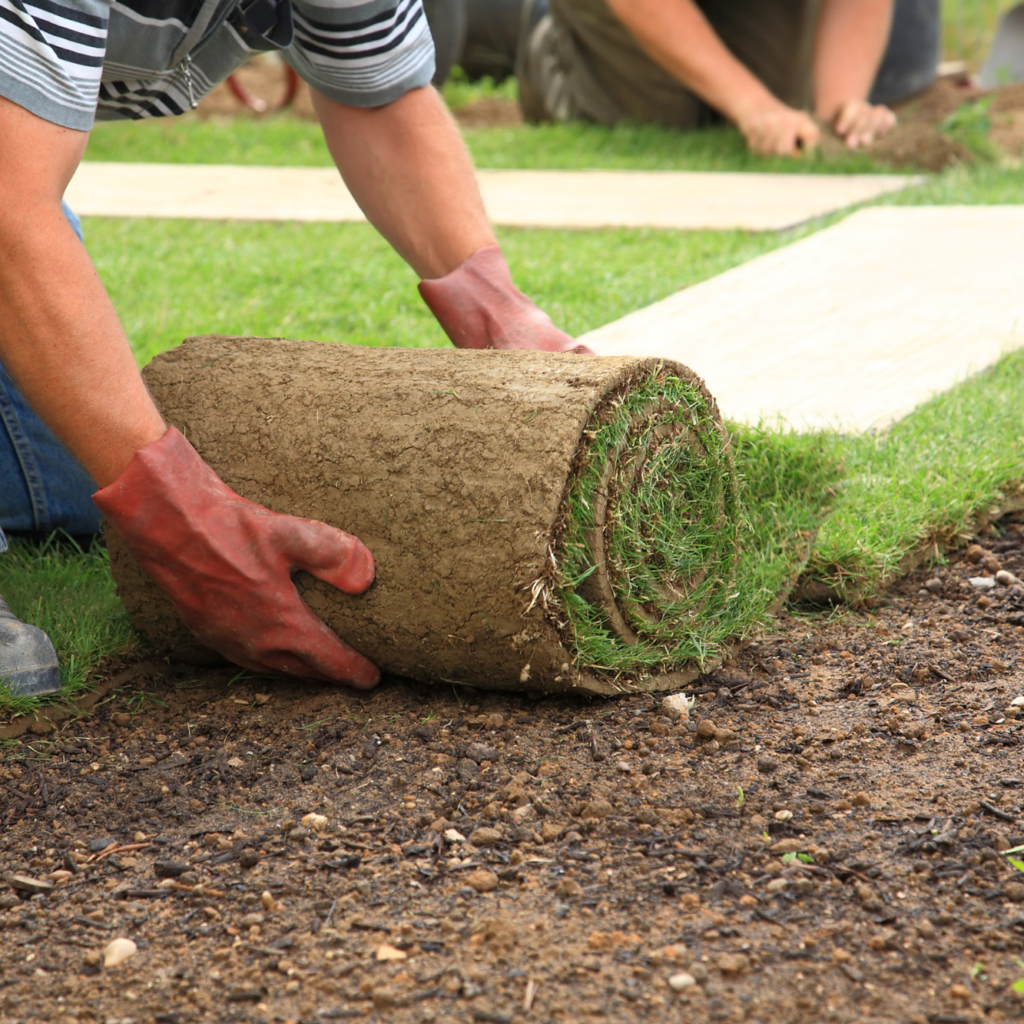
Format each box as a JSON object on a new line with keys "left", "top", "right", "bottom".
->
{"left": 555, "top": 373, "right": 745, "bottom": 674}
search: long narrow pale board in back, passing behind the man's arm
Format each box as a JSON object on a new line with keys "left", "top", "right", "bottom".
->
{"left": 66, "top": 163, "right": 922, "bottom": 230}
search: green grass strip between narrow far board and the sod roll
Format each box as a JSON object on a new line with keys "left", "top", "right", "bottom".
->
{"left": 84, "top": 217, "right": 790, "bottom": 365}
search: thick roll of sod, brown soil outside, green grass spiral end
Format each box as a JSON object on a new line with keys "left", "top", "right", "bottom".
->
{"left": 110, "top": 337, "right": 742, "bottom": 694}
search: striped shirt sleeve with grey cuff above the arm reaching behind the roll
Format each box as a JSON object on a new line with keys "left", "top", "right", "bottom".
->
{"left": 285, "top": 0, "right": 434, "bottom": 106}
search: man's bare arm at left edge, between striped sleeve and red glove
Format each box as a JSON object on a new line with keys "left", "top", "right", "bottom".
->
{"left": 0, "top": 93, "right": 165, "bottom": 486}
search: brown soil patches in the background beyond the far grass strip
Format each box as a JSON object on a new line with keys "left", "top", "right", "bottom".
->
{"left": 199, "top": 57, "right": 1024, "bottom": 171}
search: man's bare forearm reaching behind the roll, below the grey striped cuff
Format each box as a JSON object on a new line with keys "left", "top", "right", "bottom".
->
{"left": 313, "top": 87, "right": 495, "bottom": 278}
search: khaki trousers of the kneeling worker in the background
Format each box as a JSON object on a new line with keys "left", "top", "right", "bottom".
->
{"left": 516, "top": 0, "right": 819, "bottom": 128}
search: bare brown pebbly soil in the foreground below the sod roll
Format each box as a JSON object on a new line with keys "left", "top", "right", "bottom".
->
{"left": 0, "top": 517, "right": 1024, "bottom": 1024}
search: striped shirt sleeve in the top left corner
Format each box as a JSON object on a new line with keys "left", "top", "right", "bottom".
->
{"left": 0, "top": 0, "right": 110, "bottom": 131}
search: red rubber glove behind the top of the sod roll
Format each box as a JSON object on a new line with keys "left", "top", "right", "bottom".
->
{"left": 420, "top": 246, "right": 594, "bottom": 355}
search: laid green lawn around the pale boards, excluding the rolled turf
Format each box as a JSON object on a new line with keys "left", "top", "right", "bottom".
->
{"left": 0, "top": 101, "right": 1024, "bottom": 711}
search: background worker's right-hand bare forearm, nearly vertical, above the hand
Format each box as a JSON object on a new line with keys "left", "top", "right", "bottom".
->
{"left": 814, "top": 0, "right": 893, "bottom": 121}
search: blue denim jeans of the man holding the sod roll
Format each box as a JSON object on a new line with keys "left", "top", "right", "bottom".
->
{"left": 0, "top": 206, "right": 101, "bottom": 551}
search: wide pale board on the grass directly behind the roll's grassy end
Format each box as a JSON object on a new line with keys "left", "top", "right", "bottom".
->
{"left": 581, "top": 206, "right": 1024, "bottom": 430}
